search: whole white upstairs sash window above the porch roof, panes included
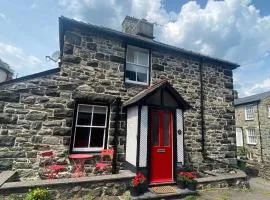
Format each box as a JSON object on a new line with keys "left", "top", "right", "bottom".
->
{"left": 125, "top": 46, "right": 149, "bottom": 85}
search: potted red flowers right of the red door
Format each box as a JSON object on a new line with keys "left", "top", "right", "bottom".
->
{"left": 177, "top": 172, "right": 198, "bottom": 191}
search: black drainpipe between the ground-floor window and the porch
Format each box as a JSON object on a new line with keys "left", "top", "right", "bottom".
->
{"left": 112, "top": 97, "right": 121, "bottom": 174}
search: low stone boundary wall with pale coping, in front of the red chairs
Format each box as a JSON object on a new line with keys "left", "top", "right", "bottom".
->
{"left": 0, "top": 170, "right": 135, "bottom": 199}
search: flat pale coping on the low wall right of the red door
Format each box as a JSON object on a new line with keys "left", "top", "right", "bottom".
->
{"left": 197, "top": 170, "right": 247, "bottom": 183}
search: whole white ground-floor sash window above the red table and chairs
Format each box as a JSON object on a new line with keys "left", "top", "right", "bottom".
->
{"left": 72, "top": 104, "right": 108, "bottom": 151}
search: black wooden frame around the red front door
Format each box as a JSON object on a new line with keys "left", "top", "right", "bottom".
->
{"left": 147, "top": 106, "right": 177, "bottom": 184}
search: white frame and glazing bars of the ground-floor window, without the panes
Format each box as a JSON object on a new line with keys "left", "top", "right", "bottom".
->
{"left": 72, "top": 104, "right": 108, "bottom": 152}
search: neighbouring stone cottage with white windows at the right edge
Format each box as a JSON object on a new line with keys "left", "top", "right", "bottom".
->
{"left": 234, "top": 91, "right": 270, "bottom": 178}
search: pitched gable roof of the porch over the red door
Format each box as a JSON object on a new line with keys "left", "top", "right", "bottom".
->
{"left": 123, "top": 80, "right": 191, "bottom": 110}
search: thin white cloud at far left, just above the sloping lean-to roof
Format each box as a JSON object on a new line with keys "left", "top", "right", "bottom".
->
{"left": 0, "top": 42, "right": 56, "bottom": 76}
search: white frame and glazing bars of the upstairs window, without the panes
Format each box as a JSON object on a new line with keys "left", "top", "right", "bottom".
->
{"left": 125, "top": 45, "right": 150, "bottom": 85}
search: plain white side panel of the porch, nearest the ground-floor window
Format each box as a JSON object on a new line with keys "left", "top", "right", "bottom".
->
{"left": 126, "top": 106, "right": 138, "bottom": 166}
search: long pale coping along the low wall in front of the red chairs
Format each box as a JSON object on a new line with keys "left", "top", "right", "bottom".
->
{"left": 0, "top": 170, "right": 135, "bottom": 193}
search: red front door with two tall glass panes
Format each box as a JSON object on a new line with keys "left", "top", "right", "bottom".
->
{"left": 150, "top": 110, "right": 173, "bottom": 183}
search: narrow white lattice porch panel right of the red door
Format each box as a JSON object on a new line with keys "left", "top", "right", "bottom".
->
{"left": 176, "top": 109, "right": 184, "bottom": 164}
